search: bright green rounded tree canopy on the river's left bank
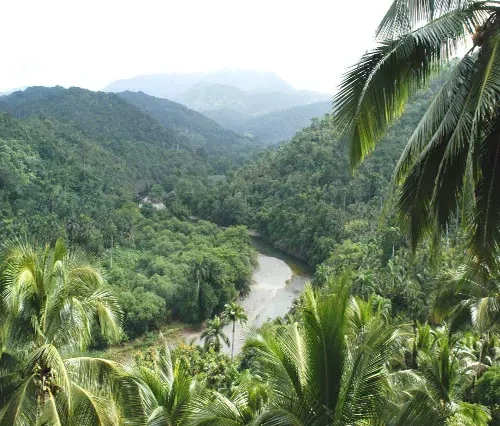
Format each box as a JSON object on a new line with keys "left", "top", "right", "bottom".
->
{"left": 104, "top": 220, "right": 256, "bottom": 337}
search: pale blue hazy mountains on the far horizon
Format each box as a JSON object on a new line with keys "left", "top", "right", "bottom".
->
{"left": 104, "top": 71, "right": 331, "bottom": 144}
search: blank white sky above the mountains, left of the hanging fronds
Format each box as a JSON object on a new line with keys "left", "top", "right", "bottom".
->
{"left": 0, "top": 0, "right": 392, "bottom": 92}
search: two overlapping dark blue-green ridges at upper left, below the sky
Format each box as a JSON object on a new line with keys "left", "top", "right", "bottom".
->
{"left": 0, "top": 86, "right": 259, "bottom": 162}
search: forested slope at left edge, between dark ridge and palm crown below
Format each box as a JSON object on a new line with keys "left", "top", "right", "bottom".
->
{"left": 0, "top": 113, "right": 208, "bottom": 245}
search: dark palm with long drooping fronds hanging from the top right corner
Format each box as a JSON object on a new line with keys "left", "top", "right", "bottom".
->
{"left": 334, "top": 0, "right": 500, "bottom": 265}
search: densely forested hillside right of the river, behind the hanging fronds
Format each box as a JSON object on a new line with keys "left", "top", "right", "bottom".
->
{"left": 192, "top": 81, "right": 444, "bottom": 265}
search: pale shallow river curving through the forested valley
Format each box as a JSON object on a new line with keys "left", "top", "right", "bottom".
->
{"left": 184, "top": 238, "right": 311, "bottom": 354}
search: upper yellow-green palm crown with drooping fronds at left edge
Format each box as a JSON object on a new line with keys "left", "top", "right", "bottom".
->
{"left": 0, "top": 241, "right": 122, "bottom": 350}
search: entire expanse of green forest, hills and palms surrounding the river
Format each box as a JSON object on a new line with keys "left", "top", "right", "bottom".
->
{"left": 0, "top": 0, "right": 500, "bottom": 426}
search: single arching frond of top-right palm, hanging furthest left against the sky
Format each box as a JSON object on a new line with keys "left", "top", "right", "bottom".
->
{"left": 334, "top": 6, "right": 484, "bottom": 167}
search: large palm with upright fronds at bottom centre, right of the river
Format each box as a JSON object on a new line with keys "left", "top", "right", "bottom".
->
{"left": 240, "top": 278, "right": 402, "bottom": 426}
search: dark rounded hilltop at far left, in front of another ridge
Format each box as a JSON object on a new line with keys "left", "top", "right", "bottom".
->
{"left": 0, "top": 86, "right": 182, "bottom": 148}
